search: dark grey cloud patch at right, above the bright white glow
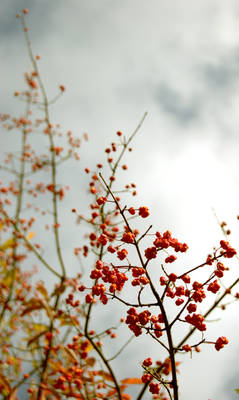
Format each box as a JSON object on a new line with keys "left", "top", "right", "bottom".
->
{"left": 152, "top": 48, "right": 239, "bottom": 131}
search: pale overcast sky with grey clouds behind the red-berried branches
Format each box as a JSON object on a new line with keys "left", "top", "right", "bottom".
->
{"left": 0, "top": 0, "right": 239, "bottom": 400}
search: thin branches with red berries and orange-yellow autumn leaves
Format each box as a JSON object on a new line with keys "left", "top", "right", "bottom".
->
{"left": 0, "top": 9, "right": 238, "bottom": 400}
